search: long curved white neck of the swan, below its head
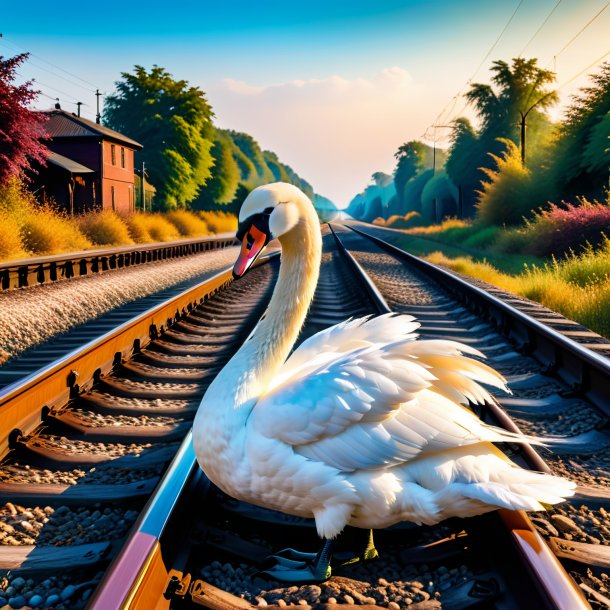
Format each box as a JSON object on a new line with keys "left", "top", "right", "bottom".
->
{"left": 214, "top": 218, "right": 322, "bottom": 408}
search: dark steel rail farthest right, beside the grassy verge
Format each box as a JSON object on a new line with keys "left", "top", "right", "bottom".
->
{"left": 345, "top": 225, "right": 610, "bottom": 415}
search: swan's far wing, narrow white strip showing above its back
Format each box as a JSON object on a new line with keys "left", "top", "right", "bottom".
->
{"left": 272, "top": 313, "right": 420, "bottom": 387}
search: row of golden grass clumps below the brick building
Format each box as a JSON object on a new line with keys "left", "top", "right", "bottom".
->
{"left": 0, "top": 180, "right": 237, "bottom": 261}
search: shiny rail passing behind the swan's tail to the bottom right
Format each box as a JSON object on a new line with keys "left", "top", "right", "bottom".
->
{"left": 331, "top": 227, "right": 590, "bottom": 610}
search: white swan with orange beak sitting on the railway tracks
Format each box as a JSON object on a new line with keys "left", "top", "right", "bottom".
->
{"left": 193, "top": 182, "right": 575, "bottom": 582}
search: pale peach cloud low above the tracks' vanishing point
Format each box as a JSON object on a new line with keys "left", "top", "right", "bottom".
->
{"left": 208, "top": 66, "right": 422, "bottom": 205}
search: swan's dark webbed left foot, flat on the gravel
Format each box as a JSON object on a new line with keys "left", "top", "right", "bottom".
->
{"left": 259, "top": 540, "right": 333, "bottom": 584}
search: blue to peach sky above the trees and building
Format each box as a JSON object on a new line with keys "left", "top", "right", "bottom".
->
{"left": 0, "top": 0, "right": 610, "bottom": 207}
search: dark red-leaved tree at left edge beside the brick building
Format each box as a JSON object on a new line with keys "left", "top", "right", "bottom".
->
{"left": 0, "top": 53, "right": 48, "bottom": 186}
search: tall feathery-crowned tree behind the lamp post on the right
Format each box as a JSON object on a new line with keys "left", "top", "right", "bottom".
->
{"left": 466, "top": 57, "right": 558, "bottom": 162}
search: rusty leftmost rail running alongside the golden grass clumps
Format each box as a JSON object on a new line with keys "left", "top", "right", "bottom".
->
{"left": 0, "top": 233, "right": 237, "bottom": 291}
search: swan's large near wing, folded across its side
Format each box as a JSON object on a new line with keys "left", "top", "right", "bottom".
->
{"left": 251, "top": 332, "right": 534, "bottom": 470}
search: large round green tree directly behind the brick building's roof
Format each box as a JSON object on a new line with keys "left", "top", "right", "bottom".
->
{"left": 104, "top": 65, "right": 214, "bottom": 209}
